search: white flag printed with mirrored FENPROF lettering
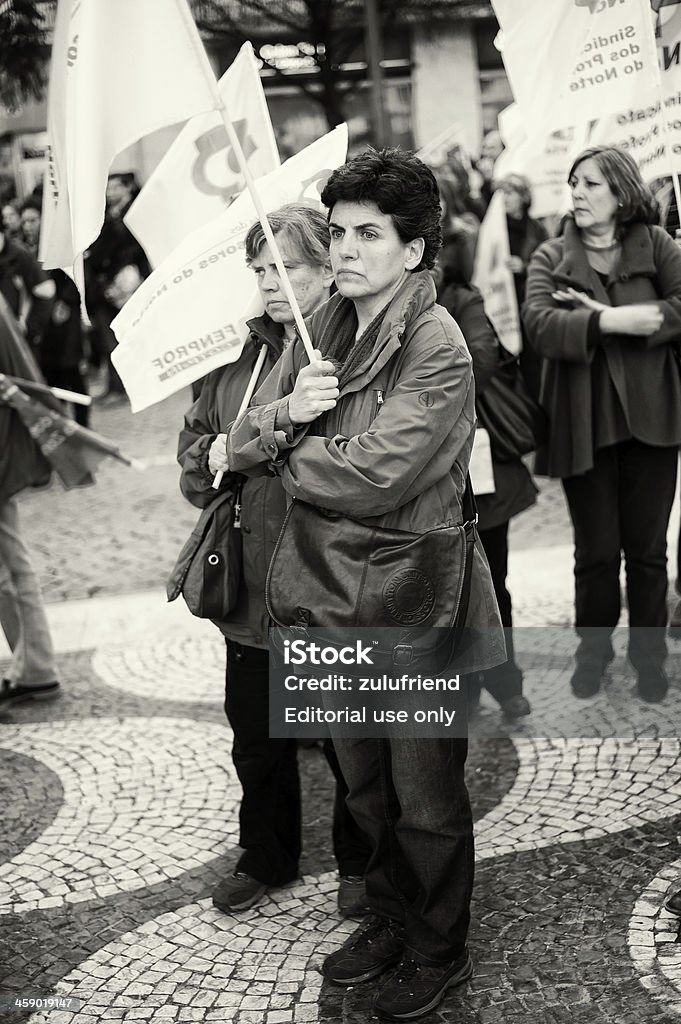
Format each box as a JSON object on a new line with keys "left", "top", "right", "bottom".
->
{"left": 112, "top": 125, "right": 347, "bottom": 413}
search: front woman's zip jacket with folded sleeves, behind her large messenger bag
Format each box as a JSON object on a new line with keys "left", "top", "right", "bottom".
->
{"left": 227, "top": 271, "right": 505, "bottom": 669}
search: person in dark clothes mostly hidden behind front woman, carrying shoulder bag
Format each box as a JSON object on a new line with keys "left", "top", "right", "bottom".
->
{"left": 439, "top": 261, "right": 537, "bottom": 718}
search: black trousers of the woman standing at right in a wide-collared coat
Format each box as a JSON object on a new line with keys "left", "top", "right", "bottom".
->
{"left": 562, "top": 440, "right": 678, "bottom": 671}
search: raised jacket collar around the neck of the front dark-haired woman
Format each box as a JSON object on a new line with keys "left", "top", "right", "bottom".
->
{"left": 311, "top": 270, "right": 435, "bottom": 394}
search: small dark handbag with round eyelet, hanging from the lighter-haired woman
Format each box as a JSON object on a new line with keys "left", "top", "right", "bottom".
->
{"left": 166, "top": 486, "right": 242, "bottom": 622}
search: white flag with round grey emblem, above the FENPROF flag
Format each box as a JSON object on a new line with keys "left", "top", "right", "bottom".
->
{"left": 124, "top": 43, "right": 280, "bottom": 266}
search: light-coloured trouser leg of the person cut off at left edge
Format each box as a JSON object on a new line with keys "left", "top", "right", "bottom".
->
{"left": 0, "top": 499, "right": 56, "bottom": 686}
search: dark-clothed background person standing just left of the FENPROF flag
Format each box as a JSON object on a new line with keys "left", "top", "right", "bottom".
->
{"left": 85, "top": 174, "right": 151, "bottom": 399}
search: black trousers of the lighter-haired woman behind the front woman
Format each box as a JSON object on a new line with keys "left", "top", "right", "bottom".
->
{"left": 224, "top": 640, "right": 369, "bottom": 886}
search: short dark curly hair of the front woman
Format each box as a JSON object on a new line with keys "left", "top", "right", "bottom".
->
{"left": 322, "top": 148, "right": 442, "bottom": 270}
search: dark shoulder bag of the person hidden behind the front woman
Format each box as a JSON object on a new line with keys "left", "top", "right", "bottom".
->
{"left": 475, "top": 342, "right": 547, "bottom": 462}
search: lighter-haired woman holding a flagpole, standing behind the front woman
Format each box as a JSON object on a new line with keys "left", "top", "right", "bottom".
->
{"left": 173, "top": 204, "right": 369, "bottom": 915}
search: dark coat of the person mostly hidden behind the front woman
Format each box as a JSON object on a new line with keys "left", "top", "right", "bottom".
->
{"left": 439, "top": 284, "right": 537, "bottom": 530}
